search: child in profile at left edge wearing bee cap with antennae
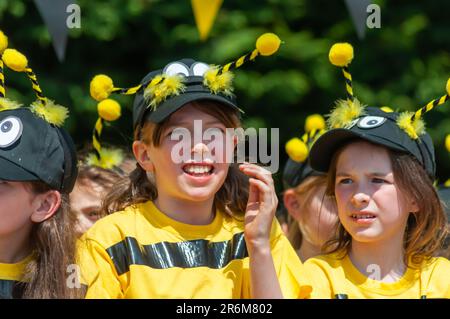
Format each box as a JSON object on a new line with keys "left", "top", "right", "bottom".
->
{"left": 0, "top": 31, "right": 82, "bottom": 298}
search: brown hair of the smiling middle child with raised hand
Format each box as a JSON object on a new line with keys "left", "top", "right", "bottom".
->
{"left": 102, "top": 100, "right": 248, "bottom": 216}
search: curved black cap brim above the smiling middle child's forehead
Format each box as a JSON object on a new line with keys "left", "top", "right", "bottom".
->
{"left": 146, "top": 92, "right": 243, "bottom": 123}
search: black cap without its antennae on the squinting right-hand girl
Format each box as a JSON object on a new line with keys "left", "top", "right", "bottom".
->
{"left": 309, "top": 107, "right": 436, "bottom": 178}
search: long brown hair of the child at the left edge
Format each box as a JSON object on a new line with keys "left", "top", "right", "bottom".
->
{"left": 22, "top": 182, "right": 84, "bottom": 299}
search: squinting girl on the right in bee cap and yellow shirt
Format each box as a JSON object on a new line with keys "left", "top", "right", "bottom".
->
{"left": 305, "top": 43, "right": 450, "bottom": 298}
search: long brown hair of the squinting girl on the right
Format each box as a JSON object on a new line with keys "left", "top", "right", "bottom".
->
{"left": 326, "top": 144, "right": 448, "bottom": 266}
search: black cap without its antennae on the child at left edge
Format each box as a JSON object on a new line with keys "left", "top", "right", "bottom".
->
{"left": 0, "top": 107, "right": 78, "bottom": 193}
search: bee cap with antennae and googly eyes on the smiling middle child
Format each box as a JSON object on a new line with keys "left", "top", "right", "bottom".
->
{"left": 90, "top": 33, "right": 281, "bottom": 128}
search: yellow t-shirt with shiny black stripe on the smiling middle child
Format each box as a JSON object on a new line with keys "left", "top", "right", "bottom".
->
{"left": 79, "top": 201, "right": 310, "bottom": 298}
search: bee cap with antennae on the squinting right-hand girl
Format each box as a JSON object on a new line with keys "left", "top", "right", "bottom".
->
{"left": 310, "top": 43, "right": 450, "bottom": 178}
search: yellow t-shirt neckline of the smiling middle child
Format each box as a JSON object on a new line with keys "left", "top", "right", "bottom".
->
{"left": 145, "top": 201, "right": 223, "bottom": 237}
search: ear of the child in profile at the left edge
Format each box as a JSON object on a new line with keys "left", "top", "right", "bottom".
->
{"left": 31, "top": 190, "right": 61, "bottom": 223}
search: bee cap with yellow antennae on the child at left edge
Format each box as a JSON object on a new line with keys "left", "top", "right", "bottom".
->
{"left": 0, "top": 31, "right": 77, "bottom": 193}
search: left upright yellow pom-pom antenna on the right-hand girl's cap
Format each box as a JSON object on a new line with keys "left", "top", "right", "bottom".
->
{"left": 328, "top": 43, "right": 355, "bottom": 102}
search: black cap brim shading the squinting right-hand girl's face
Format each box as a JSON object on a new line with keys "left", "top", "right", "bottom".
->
{"left": 309, "top": 129, "right": 406, "bottom": 173}
